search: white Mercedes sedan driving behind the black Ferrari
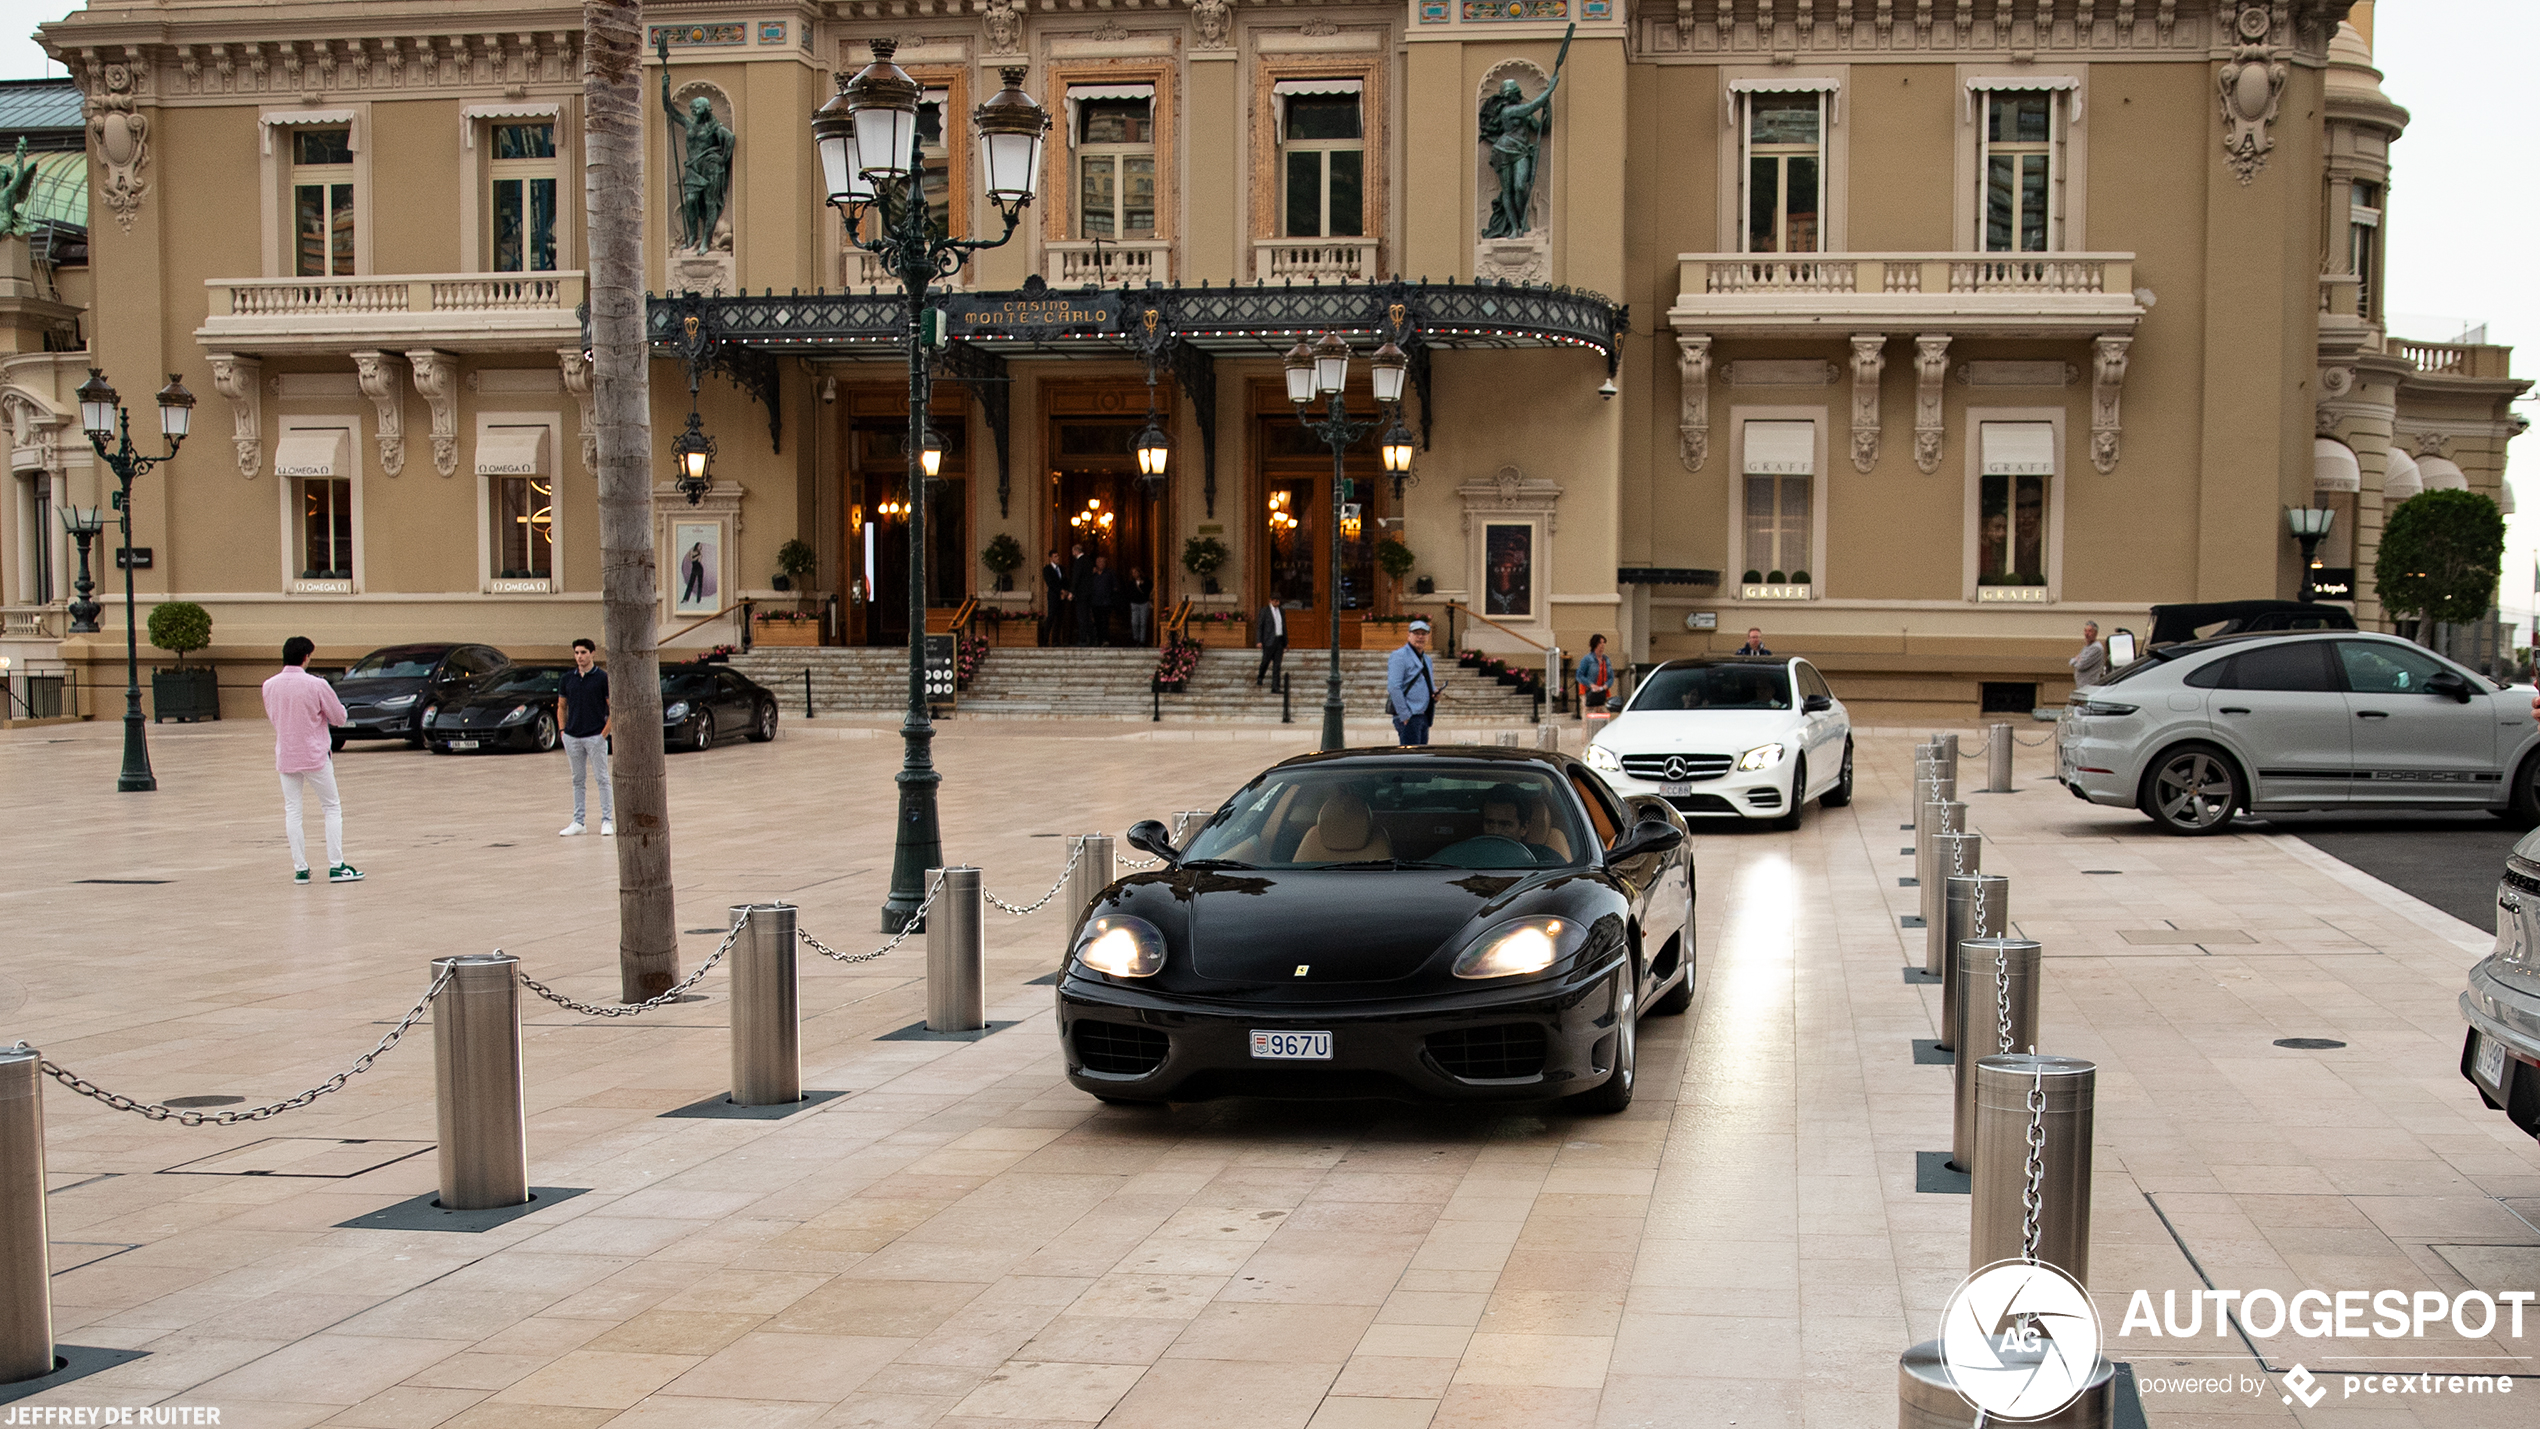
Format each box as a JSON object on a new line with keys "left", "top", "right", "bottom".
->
{"left": 1588, "top": 655, "right": 1852, "bottom": 827}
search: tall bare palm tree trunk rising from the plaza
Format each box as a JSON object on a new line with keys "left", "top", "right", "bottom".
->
{"left": 582, "top": 0, "right": 678, "bottom": 1003}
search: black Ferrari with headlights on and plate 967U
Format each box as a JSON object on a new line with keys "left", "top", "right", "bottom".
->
{"left": 1057, "top": 746, "right": 1694, "bottom": 1112}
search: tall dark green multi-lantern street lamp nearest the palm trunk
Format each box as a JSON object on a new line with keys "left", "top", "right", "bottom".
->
{"left": 810, "top": 38, "right": 1049, "bottom": 932}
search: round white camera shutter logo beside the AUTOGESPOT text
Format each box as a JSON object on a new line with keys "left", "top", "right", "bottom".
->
{"left": 1941, "top": 1261, "right": 2101, "bottom": 1424}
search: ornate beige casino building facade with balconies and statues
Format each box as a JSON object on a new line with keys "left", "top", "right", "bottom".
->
{"left": 0, "top": 0, "right": 2525, "bottom": 721}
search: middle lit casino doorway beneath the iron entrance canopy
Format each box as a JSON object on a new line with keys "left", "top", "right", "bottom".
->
{"left": 1044, "top": 383, "right": 1179, "bottom": 645}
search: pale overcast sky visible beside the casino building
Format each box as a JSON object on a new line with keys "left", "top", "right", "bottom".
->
{"left": 0, "top": 0, "right": 2540, "bottom": 614}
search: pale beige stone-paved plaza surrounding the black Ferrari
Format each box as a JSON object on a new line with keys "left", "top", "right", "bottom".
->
{"left": 0, "top": 721, "right": 2540, "bottom": 1429}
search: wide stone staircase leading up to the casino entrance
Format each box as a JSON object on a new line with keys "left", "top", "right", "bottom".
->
{"left": 732, "top": 645, "right": 1534, "bottom": 726}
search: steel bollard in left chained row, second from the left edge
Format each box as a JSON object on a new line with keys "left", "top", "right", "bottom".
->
{"left": 432, "top": 952, "right": 528, "bottom": 1211}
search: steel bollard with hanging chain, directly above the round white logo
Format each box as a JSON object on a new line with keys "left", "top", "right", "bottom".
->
{"left": 1966, "top": 1053, "right": 2098, "bottom": 1284}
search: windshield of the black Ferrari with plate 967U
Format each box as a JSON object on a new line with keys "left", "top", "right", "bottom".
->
{"left": 1184, "top": 759, "right": 1593, "bottom": 868}
